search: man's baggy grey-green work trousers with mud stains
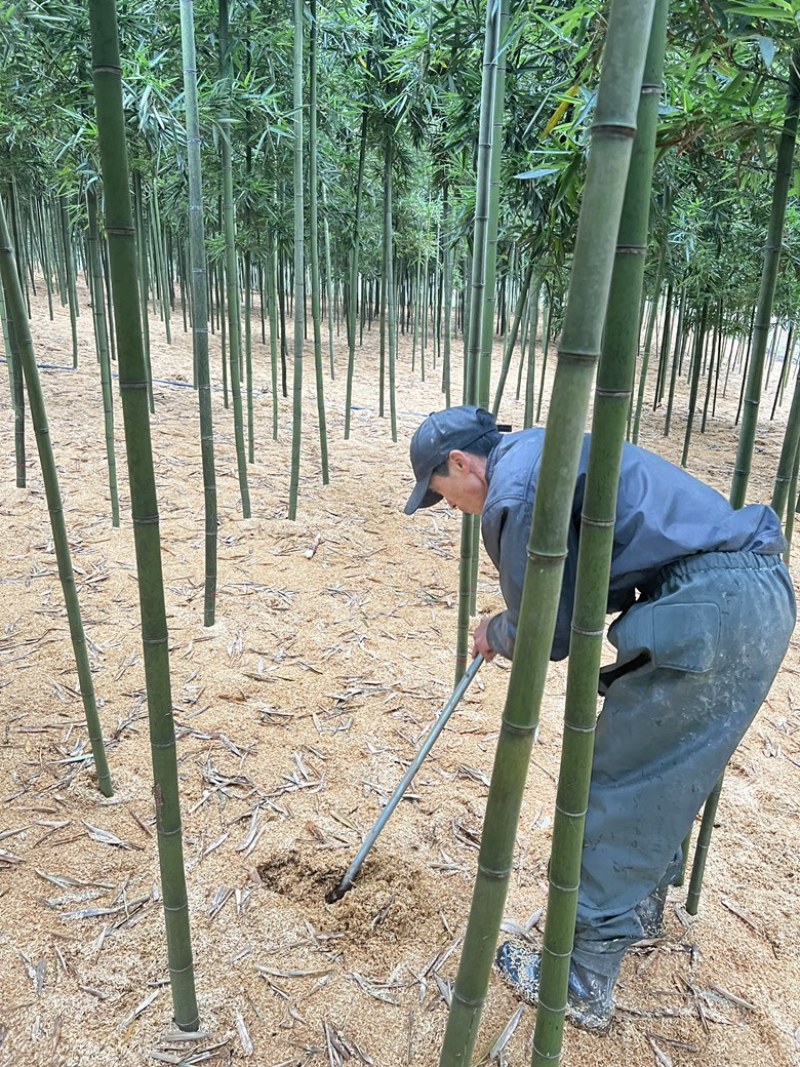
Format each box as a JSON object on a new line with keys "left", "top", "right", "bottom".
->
{"left": 574, "top": 552, "right": 795, "bottom": 966}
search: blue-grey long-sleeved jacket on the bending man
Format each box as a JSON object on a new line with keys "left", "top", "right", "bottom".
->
{"left": 481, "top": 429, "right": 784, "bottom": 659}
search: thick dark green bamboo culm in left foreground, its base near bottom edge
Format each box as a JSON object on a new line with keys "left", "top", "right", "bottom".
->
{"left": 89, "top": 0, "right": 199, "bottom": 1031}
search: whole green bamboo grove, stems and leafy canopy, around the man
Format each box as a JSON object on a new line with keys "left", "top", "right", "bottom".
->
{"left": 0, "top": 0, "right": 800, "bottom": 1064}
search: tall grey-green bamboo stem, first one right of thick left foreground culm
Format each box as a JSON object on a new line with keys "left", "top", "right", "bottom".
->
{"left": 180, "top": 0, "right": 217, "bottom": 626}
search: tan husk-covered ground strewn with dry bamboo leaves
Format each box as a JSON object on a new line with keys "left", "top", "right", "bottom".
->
{"left": 0, "top": 281, "right": 800, "bottom": 1067}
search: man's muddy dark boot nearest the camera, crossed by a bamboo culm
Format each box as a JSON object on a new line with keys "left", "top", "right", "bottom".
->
{"left": 495, "top": 941, "right": 627, "bottom": 1033}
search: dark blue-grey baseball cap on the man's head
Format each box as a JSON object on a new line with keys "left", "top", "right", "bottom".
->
{"left": 404, "top": 404, "right": 497, "bottom": 515}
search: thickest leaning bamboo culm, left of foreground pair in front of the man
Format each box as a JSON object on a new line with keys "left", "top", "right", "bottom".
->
{"left": 441, "top": 0, "right": 653, "bottom": 1067}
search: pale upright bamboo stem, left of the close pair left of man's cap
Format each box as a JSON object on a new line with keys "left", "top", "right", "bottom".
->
{"left": 289, "top": 0, "right": 305, "bottom": 519}
